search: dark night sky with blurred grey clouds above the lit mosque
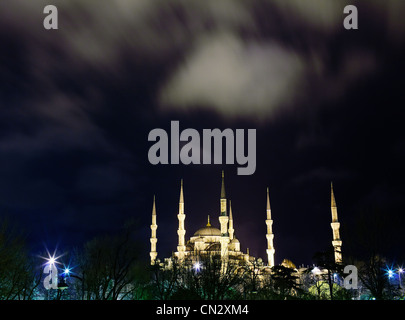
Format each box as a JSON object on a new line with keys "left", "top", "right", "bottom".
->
{"left": 0, "top": 0, "right": 405, "bottom": 265}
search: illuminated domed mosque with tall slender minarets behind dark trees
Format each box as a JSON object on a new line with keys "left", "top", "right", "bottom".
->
{"left": 150, "top": 171, "right": 342, "bottom": 269}
